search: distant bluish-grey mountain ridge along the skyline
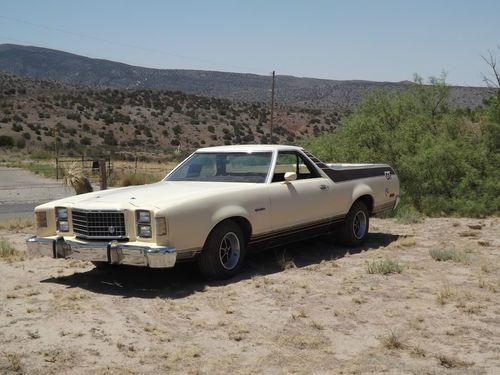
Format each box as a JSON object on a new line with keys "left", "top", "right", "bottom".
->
{"left": 0, "top": 44, "right": 493, "bottom": 111}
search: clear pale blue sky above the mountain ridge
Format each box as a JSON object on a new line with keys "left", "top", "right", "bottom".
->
{"left": 0, "top": 0, "right": 500, "bottom": 86}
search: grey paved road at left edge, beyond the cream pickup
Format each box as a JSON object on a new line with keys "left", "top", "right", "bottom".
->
{"left": 0, "top": 167, "right": 75, "bottom": 220}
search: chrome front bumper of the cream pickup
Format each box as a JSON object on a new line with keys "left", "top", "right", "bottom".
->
{"left": 26, "top": 236, "right": 177, "bottom": 268}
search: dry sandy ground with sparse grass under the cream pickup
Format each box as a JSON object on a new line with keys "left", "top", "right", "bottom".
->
{"left": 0, "top": 218, "right": 500, "bottom": 374}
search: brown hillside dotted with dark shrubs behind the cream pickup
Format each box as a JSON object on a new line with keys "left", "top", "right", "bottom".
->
{"left": 0, "top": 73, "right": 341, "bottom": 154}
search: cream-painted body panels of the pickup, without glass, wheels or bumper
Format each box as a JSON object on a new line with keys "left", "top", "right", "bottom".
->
{"left": 35, "top": 145, "right": 399, "bottom": 253}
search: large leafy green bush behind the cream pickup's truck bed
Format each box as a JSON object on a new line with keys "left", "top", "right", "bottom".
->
{"left": 304, "top": 77, "right": 500, "bottom": 217}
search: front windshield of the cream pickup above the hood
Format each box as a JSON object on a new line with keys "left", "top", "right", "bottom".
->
{"left": 166, "top": 152, "right": 272, "bottom": 183}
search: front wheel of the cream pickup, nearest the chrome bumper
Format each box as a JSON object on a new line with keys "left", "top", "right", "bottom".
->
{"left": 198, "top": 221, "right": 246, "bottom": 280}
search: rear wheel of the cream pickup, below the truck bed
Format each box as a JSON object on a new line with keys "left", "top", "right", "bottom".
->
{"left": 337, "top": 201, "right": 370, "bottom": 247}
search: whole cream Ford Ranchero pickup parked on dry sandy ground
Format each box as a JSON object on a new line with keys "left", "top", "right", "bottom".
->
{"left": 27, "top": 145, "right": 399, "bottom": 279}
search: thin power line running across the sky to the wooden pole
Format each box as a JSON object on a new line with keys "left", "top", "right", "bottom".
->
{"left": 0, "top": 15, "right": 267, "bottom": 75}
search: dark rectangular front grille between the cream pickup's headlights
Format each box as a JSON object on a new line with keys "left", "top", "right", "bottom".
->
{"left": 71, "top": 208, "right": 127, "bottom": 239}
